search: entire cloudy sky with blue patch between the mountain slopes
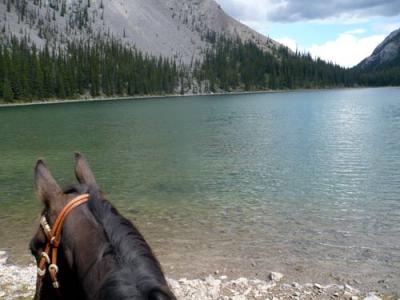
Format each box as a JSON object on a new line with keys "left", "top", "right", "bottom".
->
{"left": 216, "top": 0, "right": 400, "bottom": 67}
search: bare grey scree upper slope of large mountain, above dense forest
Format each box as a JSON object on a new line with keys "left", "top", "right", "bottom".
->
{"left": 0, "top": 0, "right": 280, "bottom": 64}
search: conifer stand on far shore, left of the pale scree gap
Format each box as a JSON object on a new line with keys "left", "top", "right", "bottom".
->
{"left": 0, "top": 38, "right": 179, "bottom": 102}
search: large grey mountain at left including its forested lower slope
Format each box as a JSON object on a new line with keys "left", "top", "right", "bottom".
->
{"left": 0, "top": 0, "right": 364, "bottom": 103}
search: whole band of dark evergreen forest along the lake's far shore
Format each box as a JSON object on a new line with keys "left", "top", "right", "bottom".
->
{"left": 0, "top": 36, "right": 400, "bottom": 103}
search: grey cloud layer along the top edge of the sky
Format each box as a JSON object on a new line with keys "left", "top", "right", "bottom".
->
{"left": 217, "top": 0, "right": 400, "bottom": 22}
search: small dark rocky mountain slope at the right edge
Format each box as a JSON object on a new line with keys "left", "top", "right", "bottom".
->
{"left": 357, "top": 28, "right": 400, "bottom": 70}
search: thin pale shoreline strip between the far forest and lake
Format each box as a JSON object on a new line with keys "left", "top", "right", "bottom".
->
{"left": 0, "top": 86, "right": 394, "bottom": 108}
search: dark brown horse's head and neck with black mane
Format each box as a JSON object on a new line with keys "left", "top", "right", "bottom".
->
{"left": 30, "top": 153, "right": 176, "bottom": 300}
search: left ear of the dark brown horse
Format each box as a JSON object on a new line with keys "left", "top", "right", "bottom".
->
{"left": 34, "top": 159, "right": 62, "bottom": 205}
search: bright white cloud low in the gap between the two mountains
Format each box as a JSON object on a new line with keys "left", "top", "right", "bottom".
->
{"left": 308, "top": 32, "right": 385, "bottom": 67}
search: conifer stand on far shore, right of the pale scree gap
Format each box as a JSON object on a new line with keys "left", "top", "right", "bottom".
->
{"left": 195, "top": 37, "right": 357, "bottom": 91}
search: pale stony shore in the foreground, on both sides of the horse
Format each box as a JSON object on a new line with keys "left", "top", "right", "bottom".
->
{"left": 0, "top": 251, "right": 390, "bottom": 300}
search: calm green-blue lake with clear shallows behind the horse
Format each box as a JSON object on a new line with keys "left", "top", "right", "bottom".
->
{"left": 0, "top": 88, "right": 400, "bottom": 292}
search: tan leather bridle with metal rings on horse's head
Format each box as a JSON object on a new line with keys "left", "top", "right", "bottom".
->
{"left": 37, "top": 194, "right": 89, "bottom": 290}
